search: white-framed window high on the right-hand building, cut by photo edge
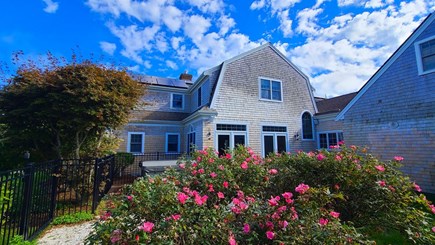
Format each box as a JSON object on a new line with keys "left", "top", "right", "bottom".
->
{"left": 415, "top": 37, "right": 435, "bottom": 75}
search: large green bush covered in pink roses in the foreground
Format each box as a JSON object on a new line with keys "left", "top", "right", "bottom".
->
{"left": 87, "top": 144, "right": 435, "bottom": 244}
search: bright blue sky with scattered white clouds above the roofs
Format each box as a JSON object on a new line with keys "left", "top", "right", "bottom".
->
{"left": 0, "top": 0, "right": 435, "bottom": 97}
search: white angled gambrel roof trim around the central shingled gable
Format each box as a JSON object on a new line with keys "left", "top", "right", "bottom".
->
{"left": 210, "top": 42, "right": 317, "bottom": 113}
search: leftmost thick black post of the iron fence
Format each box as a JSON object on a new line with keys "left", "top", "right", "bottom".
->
{"left": 19, "top": 163, "right": 35, "bottom": 239}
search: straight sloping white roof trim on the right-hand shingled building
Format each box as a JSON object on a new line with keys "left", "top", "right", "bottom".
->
{"left": 335, "top": 12, "right": 435, "bottom": 121}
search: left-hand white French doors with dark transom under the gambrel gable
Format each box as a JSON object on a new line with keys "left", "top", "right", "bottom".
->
{"left": 216, "top": 124, "right": 247, "bottom": 155}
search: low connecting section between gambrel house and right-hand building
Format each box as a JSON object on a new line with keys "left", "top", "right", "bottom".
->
{"left": 314, "top": 92, "right": 357, "bottom": 149}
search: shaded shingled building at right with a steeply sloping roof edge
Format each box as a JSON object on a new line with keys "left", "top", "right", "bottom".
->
{"left": 337, "top": 13, "right": 435, "bottom": 193}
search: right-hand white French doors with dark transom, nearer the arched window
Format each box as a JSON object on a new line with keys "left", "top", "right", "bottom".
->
{"left": 262, "top": 126, "right": 287, "bottom": 157}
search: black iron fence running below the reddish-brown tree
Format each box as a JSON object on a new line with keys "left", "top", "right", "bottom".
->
{"left": 0, "top": 152, "right": 183, "bottom": 244}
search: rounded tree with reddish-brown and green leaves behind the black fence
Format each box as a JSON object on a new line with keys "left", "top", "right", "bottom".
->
{"left": 0, "top": 53, "right": 144, "bottom": 159}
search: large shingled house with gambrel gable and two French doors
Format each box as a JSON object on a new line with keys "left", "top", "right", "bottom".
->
{"left": 120, "top": 43, "right": 317, "bottom": 156}
